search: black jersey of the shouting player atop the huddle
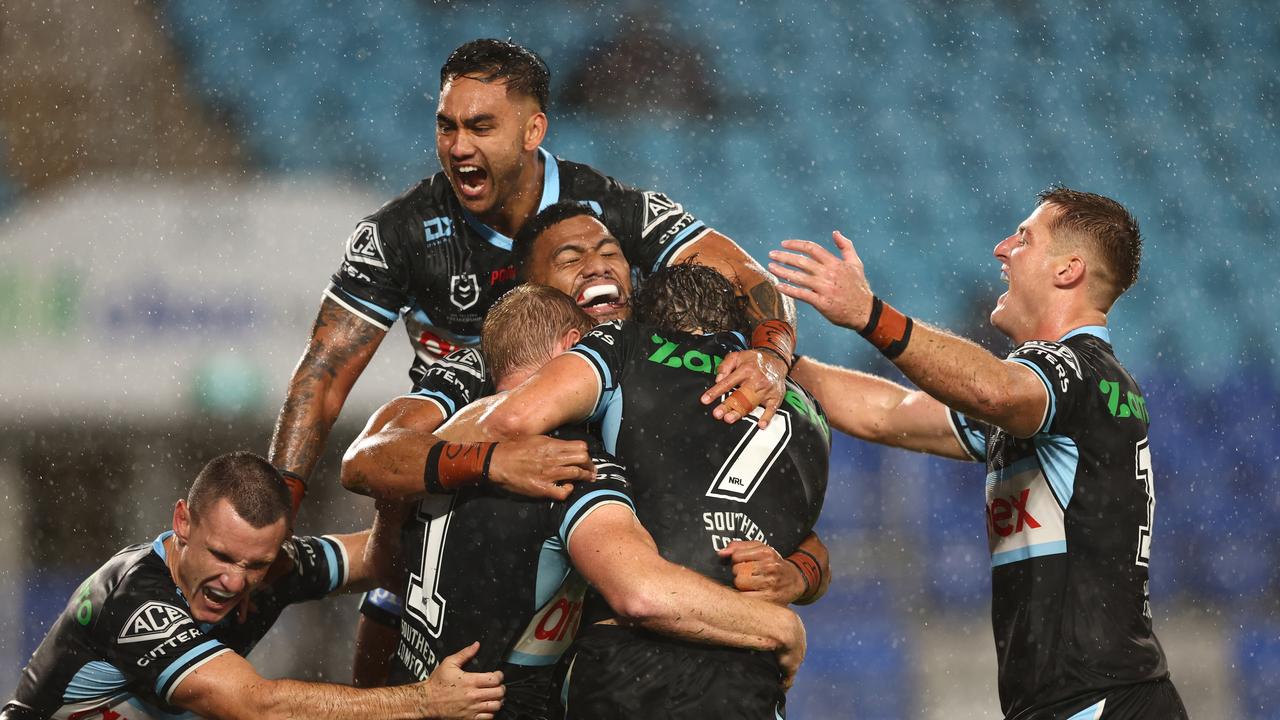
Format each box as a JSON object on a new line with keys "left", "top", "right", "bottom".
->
{"left": 325, "top": 149, "right": 710, "bottom": 363}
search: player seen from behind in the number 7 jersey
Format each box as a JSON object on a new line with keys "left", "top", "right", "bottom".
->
{"left": 439, "top": 260, "right": 831, "bottom": 717}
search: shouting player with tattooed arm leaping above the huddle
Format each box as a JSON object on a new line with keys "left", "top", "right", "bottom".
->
{"left": 269, "top": 40, "right": 795, "bottom": 512}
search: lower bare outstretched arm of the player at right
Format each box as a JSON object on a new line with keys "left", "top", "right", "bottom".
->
{"left": 791, "top": 357, "right": 970, "bottom": 460}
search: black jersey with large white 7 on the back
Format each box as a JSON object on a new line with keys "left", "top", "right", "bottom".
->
{"left": 570, "top": 322, "right": 831, "bottom": 585}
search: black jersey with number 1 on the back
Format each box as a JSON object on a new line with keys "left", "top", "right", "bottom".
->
{"left": 389, "top": 432, "right": 634, "bottom": 717}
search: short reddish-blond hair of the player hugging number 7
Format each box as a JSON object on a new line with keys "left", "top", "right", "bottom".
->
{"left": 480, "top": 283, "right": 595, "bottom": 382}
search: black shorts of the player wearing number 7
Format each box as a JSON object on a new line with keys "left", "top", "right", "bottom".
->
{"left": 562, "top": 625, "right": 786, "bottom": 720}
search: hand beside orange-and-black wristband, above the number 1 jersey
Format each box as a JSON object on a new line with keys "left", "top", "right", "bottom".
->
{"left": 489, "top": 436, "right": 595, "bottom": 500}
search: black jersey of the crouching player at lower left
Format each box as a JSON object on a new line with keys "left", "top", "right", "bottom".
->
{"left": 0, "top": 532, "right": 347, "bottom": 720}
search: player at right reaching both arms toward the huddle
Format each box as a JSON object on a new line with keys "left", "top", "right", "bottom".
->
{"left": 769, "top": 187, "right": 1187, "bottom": 720}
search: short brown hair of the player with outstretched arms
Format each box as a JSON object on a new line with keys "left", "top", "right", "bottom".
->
{"left": 1036, "top": 186, "right": 1142, "bottom": 306}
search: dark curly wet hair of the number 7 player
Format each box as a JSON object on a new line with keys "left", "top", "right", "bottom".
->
{"left": 632, "top": 258, "right": 750, "bottom": 333}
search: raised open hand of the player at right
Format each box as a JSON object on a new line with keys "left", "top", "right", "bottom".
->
{"left": 769, "top": 231, "right": 873, "bottom": 331}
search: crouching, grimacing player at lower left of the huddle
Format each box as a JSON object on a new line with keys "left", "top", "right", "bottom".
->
{"left": 0, "top": 452, "right": 503, "bottom": 720}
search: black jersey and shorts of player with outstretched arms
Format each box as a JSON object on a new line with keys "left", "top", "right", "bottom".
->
{"left": 950, "top": 325, "right": 1169, "bottom": 720}
